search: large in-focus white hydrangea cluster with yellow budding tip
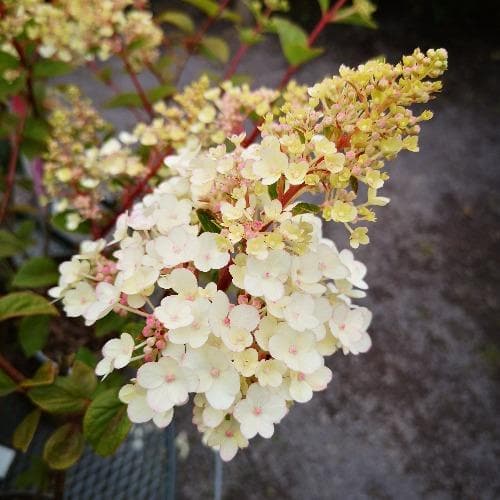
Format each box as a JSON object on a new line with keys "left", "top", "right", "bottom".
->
{"left": 51, "top": 50, "right": 446, "bottom": 460}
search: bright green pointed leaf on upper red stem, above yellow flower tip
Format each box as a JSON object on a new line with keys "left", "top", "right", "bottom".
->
{"left": 273, "top": 17, "right": 323, "bottom": 66}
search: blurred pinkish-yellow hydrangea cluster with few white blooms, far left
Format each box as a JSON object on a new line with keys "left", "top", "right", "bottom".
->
{"left": 43, "top": 87, "right": 145, "bottom": 229}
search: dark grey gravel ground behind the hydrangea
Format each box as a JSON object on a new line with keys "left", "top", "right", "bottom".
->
{"left": 62, "top": 7, "right": 500, "bottom": 500}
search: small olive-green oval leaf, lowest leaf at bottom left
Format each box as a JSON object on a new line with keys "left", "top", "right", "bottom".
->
{"left": 43, "top": 424, "right": 85, "bottom": 470}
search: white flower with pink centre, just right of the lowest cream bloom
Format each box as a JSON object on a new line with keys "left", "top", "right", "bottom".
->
{"left": 233, "top": 384, "right": 287, "bottom": 439}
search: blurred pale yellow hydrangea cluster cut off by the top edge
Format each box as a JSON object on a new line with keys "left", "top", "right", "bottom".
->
{"left": 0, "top": 0, "right": 163, "bottom": 71}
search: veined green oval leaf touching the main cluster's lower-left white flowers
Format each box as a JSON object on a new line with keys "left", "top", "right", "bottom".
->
{"left": 83, "top": 388, "right": 132, "bottom": 457}
